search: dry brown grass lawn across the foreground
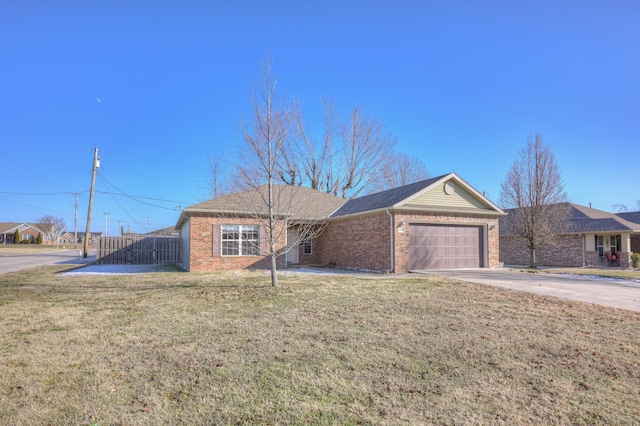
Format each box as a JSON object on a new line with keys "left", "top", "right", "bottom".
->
{"left": 0, "top": 266, "right": 640, "bottom": 425}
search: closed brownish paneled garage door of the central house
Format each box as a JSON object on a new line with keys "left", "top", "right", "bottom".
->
{"left": 409, "top": 223, "right": 484, "bottom": 270}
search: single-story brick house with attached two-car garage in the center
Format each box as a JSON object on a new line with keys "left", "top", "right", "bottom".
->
{"left": 176, "top": 173, "right": 505, "bottom": 273}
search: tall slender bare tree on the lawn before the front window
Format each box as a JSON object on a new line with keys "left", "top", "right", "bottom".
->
{"left": 236, "top": 58, "right": 338, "bottom": 287}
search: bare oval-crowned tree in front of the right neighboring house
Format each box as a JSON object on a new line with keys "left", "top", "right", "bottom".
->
{"left": 500, "top": 133, "right": 568, "bottom": 267}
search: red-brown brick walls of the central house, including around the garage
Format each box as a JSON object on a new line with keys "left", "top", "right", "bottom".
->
{"left": 185, "top": 212, "right": 500, "bottom": 273}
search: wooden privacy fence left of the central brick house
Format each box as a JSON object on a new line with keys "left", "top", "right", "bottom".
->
{"left": 96, "top": 236, "right": 180, "bottom": 265}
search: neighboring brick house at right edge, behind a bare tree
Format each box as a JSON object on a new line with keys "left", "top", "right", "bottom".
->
{"left": 500, "top": 203, "right": 640, "bottom": 267}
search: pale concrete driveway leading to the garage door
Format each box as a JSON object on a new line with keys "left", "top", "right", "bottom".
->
{"left": 411, "top": 268, "right": 640, "bottom": 312}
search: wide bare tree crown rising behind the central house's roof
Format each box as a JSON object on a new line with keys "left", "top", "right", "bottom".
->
{"left": 210, "top": 90, "right": 402, "bottom": 198}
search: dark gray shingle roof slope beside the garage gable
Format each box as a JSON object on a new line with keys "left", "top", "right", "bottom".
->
{"left": 331, "top": 175, "right": 447, "bottom": 217}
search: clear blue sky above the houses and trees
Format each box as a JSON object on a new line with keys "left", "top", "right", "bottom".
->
{"left": 0, "top": 0, "right": 640, "bottom": 235}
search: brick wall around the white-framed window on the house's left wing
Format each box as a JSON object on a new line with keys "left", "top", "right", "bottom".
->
{"left": 185, "top": 214, "right": 286, "bottom": 272}
